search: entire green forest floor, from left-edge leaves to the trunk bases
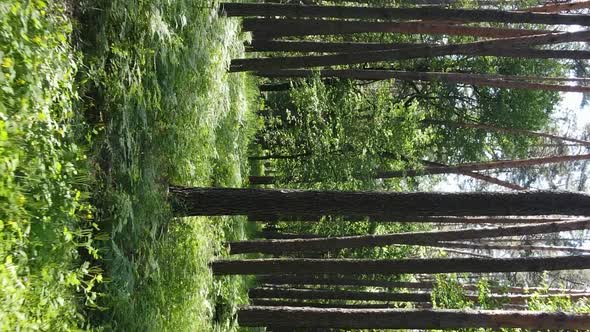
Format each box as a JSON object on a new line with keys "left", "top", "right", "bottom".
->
{"left": 0, "top": 0, "right": 258, "bottom": 332}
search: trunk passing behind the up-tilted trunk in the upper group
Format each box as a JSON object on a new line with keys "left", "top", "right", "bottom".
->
{"left": 247, "top": 39, "right": 590, "bottom": 59}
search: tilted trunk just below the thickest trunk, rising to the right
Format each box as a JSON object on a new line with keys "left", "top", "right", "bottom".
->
{"left": 229, "top": 219, "right": 590, "bottom": 254}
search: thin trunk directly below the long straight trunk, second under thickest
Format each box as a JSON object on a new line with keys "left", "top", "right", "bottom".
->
{"left": 258, "top": 275, "right": 434, "bottom": 289}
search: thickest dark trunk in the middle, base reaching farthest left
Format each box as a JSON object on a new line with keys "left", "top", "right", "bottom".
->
{"left": 169, "top": 187, "right": 590, "bottom": 219}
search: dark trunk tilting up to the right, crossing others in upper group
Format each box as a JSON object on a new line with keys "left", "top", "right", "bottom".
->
{"left": 230, "top": 31, "right": 590, "bottom": 71}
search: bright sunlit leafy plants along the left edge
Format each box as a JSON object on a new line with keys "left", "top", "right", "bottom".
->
{"left": 0, "top": 0, "right": 102, "bottom": 331}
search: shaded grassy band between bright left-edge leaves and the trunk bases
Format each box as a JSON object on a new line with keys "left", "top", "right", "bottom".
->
{"left": 81, "top": 0, "right": 256, "bottom": 331}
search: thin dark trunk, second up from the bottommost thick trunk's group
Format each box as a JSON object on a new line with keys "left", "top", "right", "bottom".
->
{"left": 248, "top": 288, "right": 430, "bottom": 302}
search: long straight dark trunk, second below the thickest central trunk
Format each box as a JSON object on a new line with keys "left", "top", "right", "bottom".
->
{"left": 212, "top": 255, "right": 590, "bottom": 275}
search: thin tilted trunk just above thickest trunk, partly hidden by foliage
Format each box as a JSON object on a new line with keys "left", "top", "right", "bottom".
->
{"left": 249, "top": 152, "right": 590, "bottom": 185}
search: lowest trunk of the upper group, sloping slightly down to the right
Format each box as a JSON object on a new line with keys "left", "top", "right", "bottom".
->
{"left": 256, "top": 69, "right": 590, "bottom": 93}
